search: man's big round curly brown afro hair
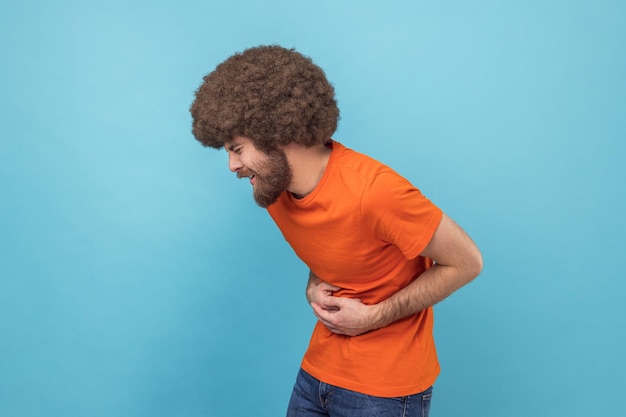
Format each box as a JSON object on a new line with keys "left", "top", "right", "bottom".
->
{"left": 190, "top": 46, "right": 339, "bottom": 151}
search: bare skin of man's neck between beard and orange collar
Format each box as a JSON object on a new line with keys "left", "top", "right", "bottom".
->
{"left": 283, "top": 143, "right": 331, "bottom": 198}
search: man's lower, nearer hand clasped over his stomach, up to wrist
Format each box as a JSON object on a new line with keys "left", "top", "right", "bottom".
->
{"left": 311, "top": 294, "right": 379, "bottom": 336}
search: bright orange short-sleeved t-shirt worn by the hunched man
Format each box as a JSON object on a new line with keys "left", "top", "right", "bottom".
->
{"left": 268, "top": 141, "right": 442, "bottom": 397}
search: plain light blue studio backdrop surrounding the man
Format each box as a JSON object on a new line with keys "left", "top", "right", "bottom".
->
{"left": 0, "top": 0, "right": 626, "bottom": 417}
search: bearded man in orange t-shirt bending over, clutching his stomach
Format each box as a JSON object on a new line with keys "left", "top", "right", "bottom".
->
{"left": 191, "top": 46, "right": 482, "bottom": 417}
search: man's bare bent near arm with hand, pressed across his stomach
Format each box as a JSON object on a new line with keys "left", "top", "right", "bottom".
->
{"left": 307, "top": 214, "right": 483, "bottom": 336}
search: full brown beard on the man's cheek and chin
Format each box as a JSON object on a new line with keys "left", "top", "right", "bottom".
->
{"left": 244, "top": 149, "right": 292, "bottom": 208}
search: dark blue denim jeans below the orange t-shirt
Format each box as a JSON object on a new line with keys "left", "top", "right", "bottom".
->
{"left": 287, "top": 369, "right": 433, "bottom": 417}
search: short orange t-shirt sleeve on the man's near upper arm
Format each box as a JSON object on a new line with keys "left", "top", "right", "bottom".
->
{"left": 361, "top": 171, "right": 442, "bottom": 259}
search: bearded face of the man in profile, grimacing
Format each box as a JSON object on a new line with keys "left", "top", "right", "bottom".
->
{"left": 224, "top": 136, "right": 292, "bottom": 208}
